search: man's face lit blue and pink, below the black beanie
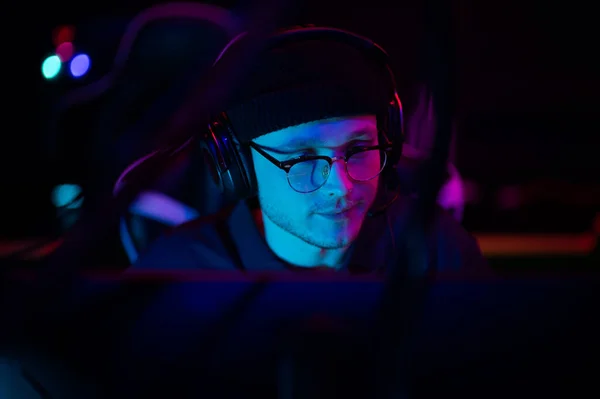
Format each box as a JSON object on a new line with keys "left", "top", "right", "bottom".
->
{"left": 252, "top": 115, "right": 381, "bottom": 249}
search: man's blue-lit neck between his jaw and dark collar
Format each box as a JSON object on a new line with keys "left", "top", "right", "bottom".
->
{"left": 253, "top": 209, "right": 348, "bottom": 268}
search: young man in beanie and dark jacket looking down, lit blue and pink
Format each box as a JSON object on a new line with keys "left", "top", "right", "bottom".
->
{"left": 134, "top": 29, "right": 485, "bottom": 272}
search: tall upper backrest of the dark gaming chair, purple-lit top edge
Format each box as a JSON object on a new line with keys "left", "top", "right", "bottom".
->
{"left": 45, "top": 2, "right": 239, "bottom": 203}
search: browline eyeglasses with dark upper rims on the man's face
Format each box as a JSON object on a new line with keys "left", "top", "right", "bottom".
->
{"left": 250, "top": 142, "right": 392, "bottom": 194}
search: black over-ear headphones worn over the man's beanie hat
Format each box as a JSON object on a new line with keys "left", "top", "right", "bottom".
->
{"left": 200, "top": 27, "right": 404, "bottom": 203}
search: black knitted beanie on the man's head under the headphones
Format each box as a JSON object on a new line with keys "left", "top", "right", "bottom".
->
{"left": 226, "top": 39, "right": 393, "bottom": 143}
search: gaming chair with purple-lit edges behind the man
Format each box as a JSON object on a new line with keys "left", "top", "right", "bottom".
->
{"left": 52, "top": 2, "right": 239, "bottom": 262}
